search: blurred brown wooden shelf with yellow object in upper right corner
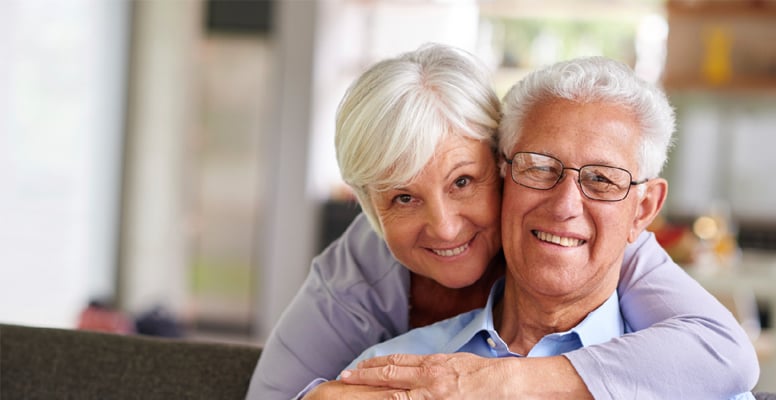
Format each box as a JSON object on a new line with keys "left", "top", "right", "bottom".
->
{"left": 664, "top": 0, "right": 776, "bottom": 90}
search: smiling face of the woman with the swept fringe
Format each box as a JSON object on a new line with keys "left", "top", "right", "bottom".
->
{"left": 371, "top": 135, "right": 502, "bottom": 288}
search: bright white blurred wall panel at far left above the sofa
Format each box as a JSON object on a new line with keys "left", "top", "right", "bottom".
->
{"left": 0, "top": 0, "right": 129, "bottom": 327}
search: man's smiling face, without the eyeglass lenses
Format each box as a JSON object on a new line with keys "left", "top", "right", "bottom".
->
{"left": 501, "top": 100, "right": 641, "bottom": 307}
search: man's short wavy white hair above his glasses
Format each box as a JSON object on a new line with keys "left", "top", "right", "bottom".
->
{"left": 499, "top": 57, "right": 676, "bottom": 180}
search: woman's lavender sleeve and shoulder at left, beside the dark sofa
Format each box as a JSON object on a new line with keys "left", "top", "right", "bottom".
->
{"left": 247, "top": 215, "right": 409, "bottom": 400}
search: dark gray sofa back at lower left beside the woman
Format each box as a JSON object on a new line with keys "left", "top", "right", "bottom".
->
{"left": 0, "top": 324, "right": 261, "bottom": 400}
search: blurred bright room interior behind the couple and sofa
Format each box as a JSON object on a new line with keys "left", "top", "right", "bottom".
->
{"left": 0, "top": 0, "right": 776, "bottom": 390}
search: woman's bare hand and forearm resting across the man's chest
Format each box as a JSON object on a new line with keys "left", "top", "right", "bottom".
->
{"left": 341, "top": 353, "right": 592, "bottom": 400}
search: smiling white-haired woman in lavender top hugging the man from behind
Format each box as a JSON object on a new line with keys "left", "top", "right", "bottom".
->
{"left": 248, "top": 45, "right": 759, "bottom": 400}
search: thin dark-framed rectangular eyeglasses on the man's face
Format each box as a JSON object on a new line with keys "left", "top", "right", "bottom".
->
{"left": 504, "top": 152, "right": 649, "bottom": 201}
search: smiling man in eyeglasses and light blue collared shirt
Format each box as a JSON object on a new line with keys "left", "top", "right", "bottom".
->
{"left": 334, "top": 57, "right": 753, "bottom": 399}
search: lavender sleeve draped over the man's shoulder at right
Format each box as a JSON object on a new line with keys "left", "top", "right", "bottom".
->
{"left": 565, "top": 232, "right": 759, "bottom": 399}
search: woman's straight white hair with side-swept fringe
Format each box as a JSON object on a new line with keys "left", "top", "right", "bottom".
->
{"left": 335, "top": 44, "right": 500, "bottom": 236}
